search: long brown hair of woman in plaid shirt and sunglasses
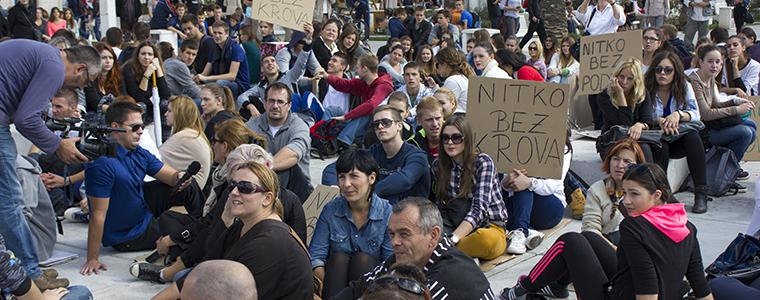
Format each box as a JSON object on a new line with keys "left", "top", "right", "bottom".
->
{"left": 435, "top": 115, "right": 478, "bottom": 201}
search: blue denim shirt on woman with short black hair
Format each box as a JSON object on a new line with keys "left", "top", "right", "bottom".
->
{"left": 309, "top": 193, "right": 393, "bottom": 268}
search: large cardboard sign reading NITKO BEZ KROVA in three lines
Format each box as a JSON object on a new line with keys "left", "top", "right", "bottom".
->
{"left": 467, "top": 77, "right": 570, "bottom": 179}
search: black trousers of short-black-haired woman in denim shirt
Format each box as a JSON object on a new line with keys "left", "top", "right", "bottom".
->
{"left": 322, "top": 252, "right": 378, "bottom": 299}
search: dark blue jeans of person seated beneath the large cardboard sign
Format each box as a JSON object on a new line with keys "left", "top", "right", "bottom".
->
{"left": 504, "top": 190, "right": 565, "bottom": 234}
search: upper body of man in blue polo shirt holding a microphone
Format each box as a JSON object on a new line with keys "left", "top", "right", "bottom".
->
{"left": 80, "top": 102, "right": 191, "bottom": 275}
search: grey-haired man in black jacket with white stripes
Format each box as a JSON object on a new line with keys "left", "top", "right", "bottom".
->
{"left": 333, "top": 197, "right": 496, "bottom": 300}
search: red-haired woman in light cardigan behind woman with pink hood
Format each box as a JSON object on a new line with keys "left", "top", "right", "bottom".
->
{"left": 581, "top": 139, "right": 645, "bottom": 245}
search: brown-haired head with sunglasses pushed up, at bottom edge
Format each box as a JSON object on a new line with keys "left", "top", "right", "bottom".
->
{"left": 361, "top": 263, "right": 431, "bottom": 300}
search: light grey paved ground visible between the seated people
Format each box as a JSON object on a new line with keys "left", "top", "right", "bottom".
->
{"left": 34, "top": 21, "right": 760, "bottom": 300}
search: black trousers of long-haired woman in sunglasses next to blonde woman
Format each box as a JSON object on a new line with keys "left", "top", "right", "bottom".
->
{"left": 652, "top": 131, "right": 707, "bottom": 186}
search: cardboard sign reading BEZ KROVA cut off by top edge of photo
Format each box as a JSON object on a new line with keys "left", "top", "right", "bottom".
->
{"left": 251, "top": 0, "right": 315, "bottom": 31}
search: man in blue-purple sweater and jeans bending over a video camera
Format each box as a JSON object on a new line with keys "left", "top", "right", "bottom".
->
{"left": 0, "top": 39, "right": 102, "bottom": 290}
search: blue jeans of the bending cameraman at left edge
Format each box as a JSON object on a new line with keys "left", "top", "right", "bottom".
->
{"left": 0, "top": 124, "right": 42, "bottom": 278}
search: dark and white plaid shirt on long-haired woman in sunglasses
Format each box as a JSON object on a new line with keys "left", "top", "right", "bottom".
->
{"left": 433, "top": 153, "right": 507, "bottom": 228}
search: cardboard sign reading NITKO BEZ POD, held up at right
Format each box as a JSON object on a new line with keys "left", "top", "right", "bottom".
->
{"left": 578, "top": 30, "right": 642, "bottom": 95}
